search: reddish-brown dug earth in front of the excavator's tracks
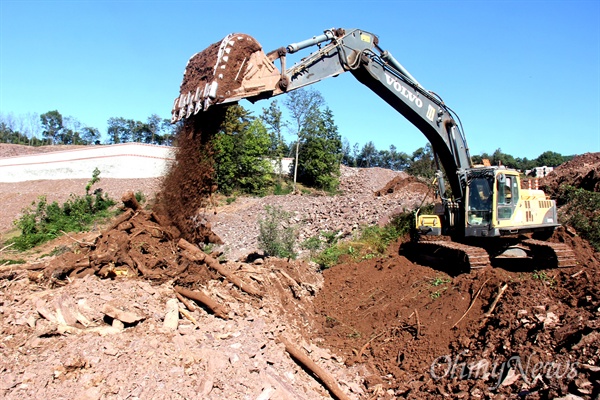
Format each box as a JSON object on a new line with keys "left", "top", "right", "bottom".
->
{"left": 315, "top": 234, "right": 600, "bottom": 399}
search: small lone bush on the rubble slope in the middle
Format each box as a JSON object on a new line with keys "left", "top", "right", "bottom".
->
{"left": 258, "top": 206, "right": 297, "bottom": 258}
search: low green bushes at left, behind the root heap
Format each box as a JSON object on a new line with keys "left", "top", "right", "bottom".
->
{"left": 7, "top": 169, "right": 115, "bottom": 251}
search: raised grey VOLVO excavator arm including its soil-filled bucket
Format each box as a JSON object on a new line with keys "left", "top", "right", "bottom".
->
{"left": 172, "top": 29, "right": 472, "bottom": 199}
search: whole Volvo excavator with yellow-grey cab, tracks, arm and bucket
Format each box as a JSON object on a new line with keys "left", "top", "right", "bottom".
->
{"left": 172, "top": 29, "right": 576, "bottom": 269}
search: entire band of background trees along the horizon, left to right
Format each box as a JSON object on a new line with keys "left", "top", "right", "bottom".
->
{"left": 0, "top": 89, "right": 572, "bottom": 194}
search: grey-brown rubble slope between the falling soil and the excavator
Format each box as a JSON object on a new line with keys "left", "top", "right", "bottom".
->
{"left": 206, "top": 166, "right": 433, "bottom": 260}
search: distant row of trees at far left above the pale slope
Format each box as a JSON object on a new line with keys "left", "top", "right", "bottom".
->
{"left": 0, "top": 110, "right": 176, "bottom": 146}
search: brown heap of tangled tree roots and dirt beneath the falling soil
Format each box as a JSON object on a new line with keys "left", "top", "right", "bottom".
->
{"left": 19, "top": 192, "right": 215, "bottom": 285}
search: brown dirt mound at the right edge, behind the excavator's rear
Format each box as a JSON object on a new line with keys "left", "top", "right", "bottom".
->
{"left": 540, "top": 153, "right": 600, "bottom": 196}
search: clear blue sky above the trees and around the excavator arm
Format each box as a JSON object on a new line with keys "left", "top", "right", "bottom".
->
{"left": 0, "top": 0, "right": 600, "bottom": 158}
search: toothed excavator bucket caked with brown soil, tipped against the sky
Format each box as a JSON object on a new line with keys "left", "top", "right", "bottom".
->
{"left": 171, "top": 33, "right": 281, "bottom": 123}
